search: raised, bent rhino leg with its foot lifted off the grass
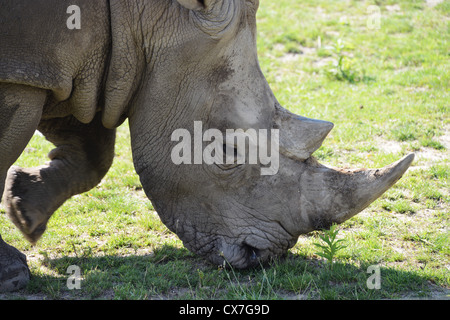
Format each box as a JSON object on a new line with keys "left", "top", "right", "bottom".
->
{"left": 4, "top": 114, "right": 115, "bottom": 244}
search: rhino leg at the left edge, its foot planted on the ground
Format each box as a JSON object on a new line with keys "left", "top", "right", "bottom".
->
{"left": 0, "top": 83, "right": 47, "bottom": 292}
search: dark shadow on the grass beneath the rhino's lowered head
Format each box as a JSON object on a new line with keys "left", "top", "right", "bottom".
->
{"left": 7, "top": 245, "right": 440, "bottom": 299}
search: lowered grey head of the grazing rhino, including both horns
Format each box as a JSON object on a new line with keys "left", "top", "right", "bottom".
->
{"left": 114, "top": 0, "right": 414, "bottom": 268}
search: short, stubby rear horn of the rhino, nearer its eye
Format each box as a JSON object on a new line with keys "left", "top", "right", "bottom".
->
{"left": 275, "top": 106, "right": 334, "bottom": 161}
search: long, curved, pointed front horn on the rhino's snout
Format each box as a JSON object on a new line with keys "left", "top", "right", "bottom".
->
{"left": 299, "top": 153, "right": 414, "bottom": 233}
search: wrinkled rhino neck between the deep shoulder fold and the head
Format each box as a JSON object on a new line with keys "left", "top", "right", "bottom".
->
{"left": 103, "top": 0, "right": 196, "bottom": 128}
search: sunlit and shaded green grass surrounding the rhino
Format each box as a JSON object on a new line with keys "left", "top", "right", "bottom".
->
{"left": 0, "top": 0, "right": 450, "bottom": 299}
